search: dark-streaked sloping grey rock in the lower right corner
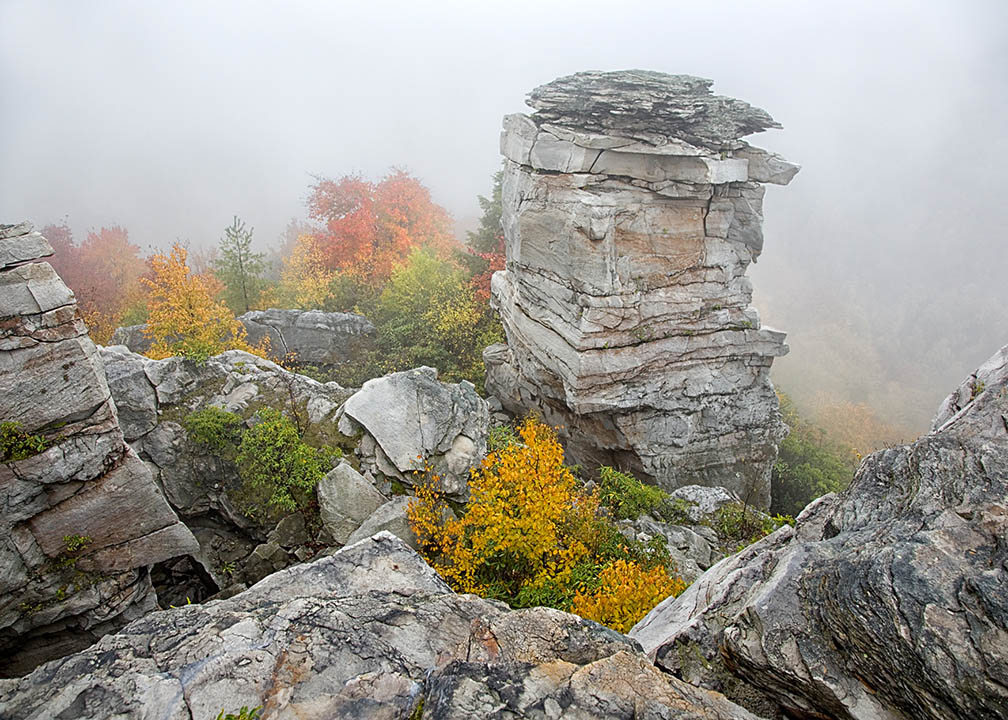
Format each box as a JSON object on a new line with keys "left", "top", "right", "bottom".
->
{"left": 630, "top": 347, "right": 1008, "bottom": 720}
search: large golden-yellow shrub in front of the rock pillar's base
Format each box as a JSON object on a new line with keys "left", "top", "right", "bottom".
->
{"left": 407, "top": 418, "right": 598, "bottom": 598}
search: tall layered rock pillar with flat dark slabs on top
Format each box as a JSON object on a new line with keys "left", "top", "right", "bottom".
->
{"left": 484, "top": 71, "right": 798, "bottom": 506}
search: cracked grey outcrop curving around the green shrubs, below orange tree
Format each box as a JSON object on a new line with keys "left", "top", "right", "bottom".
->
{"left": 95, "top": 346, "right": 354, "bottom": 602}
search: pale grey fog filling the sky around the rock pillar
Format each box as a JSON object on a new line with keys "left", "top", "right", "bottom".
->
{"left": 0, "top": 0, "right": 1008, "bottom": 432}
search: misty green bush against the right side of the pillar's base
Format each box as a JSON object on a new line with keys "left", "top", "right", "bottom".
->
{"left": 770, "top": 392, "right": 857, "bottom": 515}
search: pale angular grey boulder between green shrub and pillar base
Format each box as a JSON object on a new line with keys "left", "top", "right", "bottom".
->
{"left": 340, "top": 367, "right": 490, "bottom": 499}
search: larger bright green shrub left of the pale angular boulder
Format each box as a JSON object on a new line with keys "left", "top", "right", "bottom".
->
{"left": 235, "top": 407, "right": 339, "bottom": 511}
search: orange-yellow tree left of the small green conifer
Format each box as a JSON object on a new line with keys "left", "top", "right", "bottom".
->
{"left": 141, "top": 242, "right": 263, "bottom": 362}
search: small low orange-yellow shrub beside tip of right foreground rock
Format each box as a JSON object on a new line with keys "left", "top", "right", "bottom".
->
{"left": 573, "top": 560, "right": 686, "bottom": 632}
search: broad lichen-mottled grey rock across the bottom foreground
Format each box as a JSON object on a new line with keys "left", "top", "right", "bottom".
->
{"left": 0, "top": 533, "right": 754, "bottom": 720}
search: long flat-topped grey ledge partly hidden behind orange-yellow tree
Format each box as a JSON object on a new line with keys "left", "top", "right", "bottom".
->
{"left": 112, "top": 308, "right": 375, "bottom": 368}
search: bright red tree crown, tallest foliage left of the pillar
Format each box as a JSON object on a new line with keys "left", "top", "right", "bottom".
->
{"left": 308, "top": 170, "right": 456, "bottom": 284}
